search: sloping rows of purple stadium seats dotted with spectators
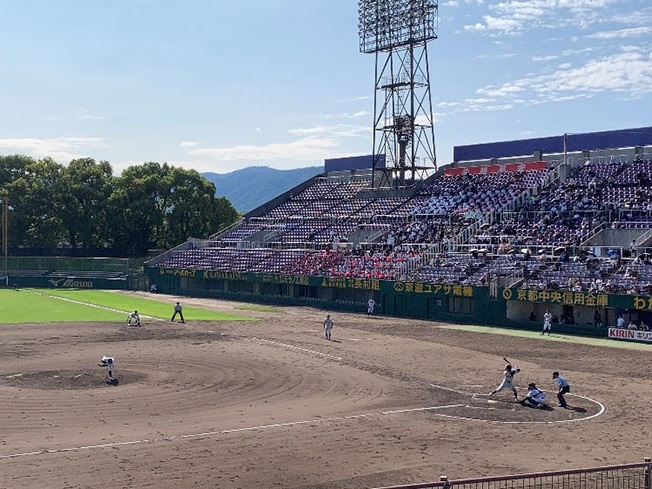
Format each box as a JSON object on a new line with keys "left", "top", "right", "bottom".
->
{"left": 154, "top": 161, "right": 652, "bottom": 293}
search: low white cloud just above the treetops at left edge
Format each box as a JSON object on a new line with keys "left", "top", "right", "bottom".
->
{"left": 0, "top": 136, "right": 108, "bottom": 163}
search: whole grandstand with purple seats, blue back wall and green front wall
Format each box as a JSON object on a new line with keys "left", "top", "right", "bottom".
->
{"left": 147, "top": 128, "right": 652, "bottom": 336}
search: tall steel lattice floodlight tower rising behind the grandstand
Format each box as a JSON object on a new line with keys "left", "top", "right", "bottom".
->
{"left": 358, "top": 0, "right": 439, "bottom": 187}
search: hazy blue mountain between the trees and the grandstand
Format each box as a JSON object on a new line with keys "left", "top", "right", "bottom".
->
{"left": 202, "top": 166, "right": 324, "bottom": 213}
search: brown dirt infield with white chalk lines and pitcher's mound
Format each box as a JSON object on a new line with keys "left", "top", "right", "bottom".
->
{"left": 0, "top": 297, "right": 652, "bottom": 488}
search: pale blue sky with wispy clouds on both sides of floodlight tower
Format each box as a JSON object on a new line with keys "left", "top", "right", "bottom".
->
{"left": 0, "top": 0, "right": 652, "bottom": 173}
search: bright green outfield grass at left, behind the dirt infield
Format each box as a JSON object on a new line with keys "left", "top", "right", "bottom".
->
{"left": 0, "top": 289, "right": 255, "bottom": 324}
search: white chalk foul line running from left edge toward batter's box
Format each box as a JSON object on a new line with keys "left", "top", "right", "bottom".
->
{"left": 0, "top": 404, "right": 462, "bottom": 460}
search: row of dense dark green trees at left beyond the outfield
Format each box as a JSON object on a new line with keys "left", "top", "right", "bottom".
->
{"left": 0, "top": 155, "right": 238, "bottom": 257}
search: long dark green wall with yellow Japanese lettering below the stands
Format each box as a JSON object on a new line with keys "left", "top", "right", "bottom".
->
{"left": 147, "top": 267, "right": 652, "bottom": 336}
